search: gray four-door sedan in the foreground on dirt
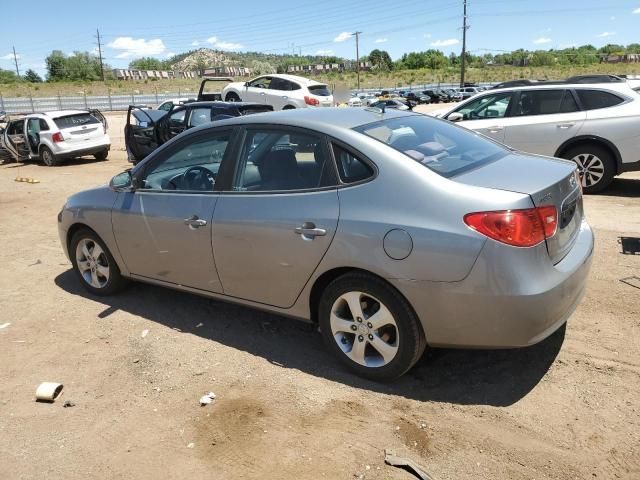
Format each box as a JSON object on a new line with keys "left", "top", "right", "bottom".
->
{"left": 58, "top": 108, "right": 593, "bottom": 380}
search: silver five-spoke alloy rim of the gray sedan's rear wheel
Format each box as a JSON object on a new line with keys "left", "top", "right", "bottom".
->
{"left": 330, "top": 292, "right": 400, "bottom": 367}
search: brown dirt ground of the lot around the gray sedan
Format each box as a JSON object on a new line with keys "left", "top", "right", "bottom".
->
{"left": 0, "top": 109, "right": 640, "bottom": 480}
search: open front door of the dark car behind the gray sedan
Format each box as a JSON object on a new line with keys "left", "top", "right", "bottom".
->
{"left": 124, "top": 105, "right": 167, "bottom": 164}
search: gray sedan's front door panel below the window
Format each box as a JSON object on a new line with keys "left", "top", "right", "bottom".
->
{"left": 112, "top": 190, "right": 222, "bottom": 293}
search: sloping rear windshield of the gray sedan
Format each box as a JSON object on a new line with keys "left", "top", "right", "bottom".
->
{"left": 354, "top": 115, "right": 509, "bottom": 177}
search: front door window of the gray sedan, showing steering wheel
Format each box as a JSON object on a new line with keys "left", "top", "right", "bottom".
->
{"left": 142, "top": 132, "right": 231, "bottom": 192}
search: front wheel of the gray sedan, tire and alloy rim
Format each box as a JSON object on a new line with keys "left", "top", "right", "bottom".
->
{"left": 69, "top": 228, "right": 126, "bottom": 295}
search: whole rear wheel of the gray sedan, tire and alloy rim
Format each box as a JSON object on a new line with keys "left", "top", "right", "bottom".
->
{"left": 318, "top": 272, "right": 426, "bottom": 381}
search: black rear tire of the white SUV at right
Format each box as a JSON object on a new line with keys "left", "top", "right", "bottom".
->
{"left": 562, "top": 143, "right": 617, "bottom": 193}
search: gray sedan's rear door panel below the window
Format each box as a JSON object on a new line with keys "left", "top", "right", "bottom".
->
{"left": 213, "top": 190, "right": 338, "bottom": 308}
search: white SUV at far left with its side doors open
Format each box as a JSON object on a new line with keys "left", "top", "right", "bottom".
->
{"left": 0, "top": 110, "right": 111, "bottom": 166}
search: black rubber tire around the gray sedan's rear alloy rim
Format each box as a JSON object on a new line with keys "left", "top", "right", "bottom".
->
{"left": 318, "top": 272, "right": 427, "bottom": 382}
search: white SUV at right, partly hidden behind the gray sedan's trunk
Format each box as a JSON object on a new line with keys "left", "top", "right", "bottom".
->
{"left": 436, "top": 81, "right": 640, "bottom": 193}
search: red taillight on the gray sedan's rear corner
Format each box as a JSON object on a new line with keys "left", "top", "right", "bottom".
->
{"left": 464, "top": 206, "right": 558, "bottom": 247}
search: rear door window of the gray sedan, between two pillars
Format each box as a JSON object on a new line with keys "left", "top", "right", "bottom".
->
{"left": 233, "top": 129, "right": 335, "bottom": 192}
